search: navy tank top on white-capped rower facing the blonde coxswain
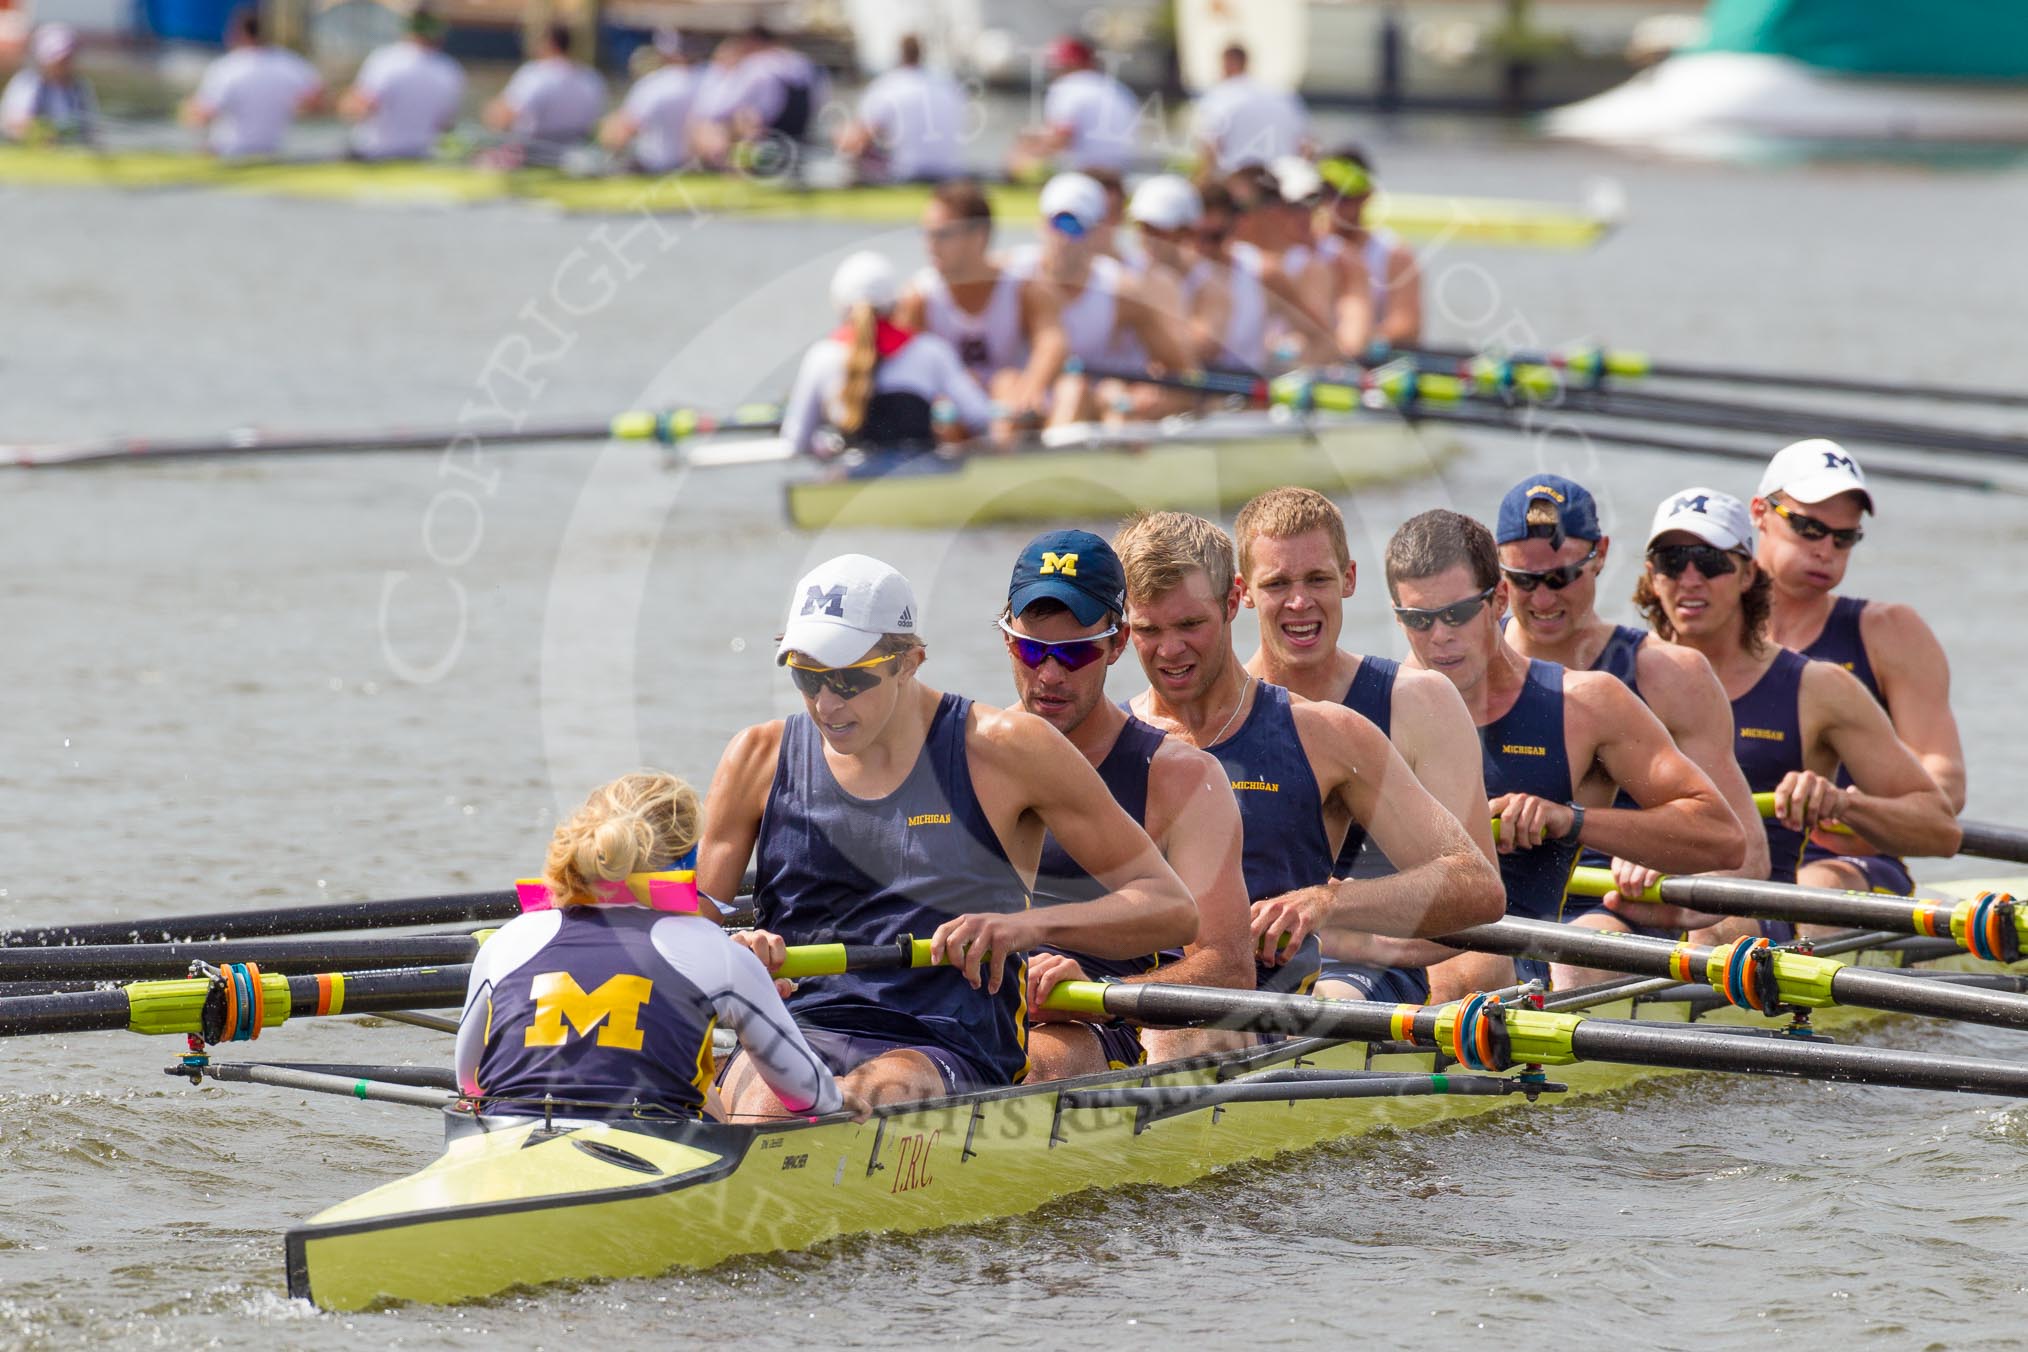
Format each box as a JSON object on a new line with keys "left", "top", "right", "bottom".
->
{"left": 754, "top": 695, "right": 1028, "bottom": 1080}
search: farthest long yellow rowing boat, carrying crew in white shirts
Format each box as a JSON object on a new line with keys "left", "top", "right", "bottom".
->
{"left": 0, "top": 146, "right": 1614, "bottom": 249}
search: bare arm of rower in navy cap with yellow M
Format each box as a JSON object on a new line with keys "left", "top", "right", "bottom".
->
{"left": 1128, "top": 738, "right": 1253, "bottom": 989}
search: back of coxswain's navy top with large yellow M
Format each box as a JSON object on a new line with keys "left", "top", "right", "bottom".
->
{"left": 479, "top": 906, "right": 718, "bottom": 1117}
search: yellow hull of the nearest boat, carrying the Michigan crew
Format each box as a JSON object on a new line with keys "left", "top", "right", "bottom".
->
{"left": 288, "top": 880, "right": 2022, "bottom": 1309}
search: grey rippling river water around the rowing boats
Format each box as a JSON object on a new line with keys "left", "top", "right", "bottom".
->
{"left": 0, "top": 116, "right": 2028, "bottom": 1348}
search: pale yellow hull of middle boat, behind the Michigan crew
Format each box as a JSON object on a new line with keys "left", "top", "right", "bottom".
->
{"left": 785, "top": 416, "right": 1458, "bottom": 531}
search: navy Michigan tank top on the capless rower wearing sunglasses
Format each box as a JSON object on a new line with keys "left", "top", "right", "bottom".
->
{"left": 1478, "top": 659, "right": 1578, "bottom": 920}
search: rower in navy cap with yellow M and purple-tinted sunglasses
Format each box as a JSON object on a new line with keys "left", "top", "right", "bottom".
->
{"left": 1000, "top": 531, "right": 1253, "bottom": 1080}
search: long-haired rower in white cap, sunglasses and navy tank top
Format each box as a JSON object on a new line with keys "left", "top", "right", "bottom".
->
{"left": 1635, "top": 489, "right": 1961, "bottom": 932}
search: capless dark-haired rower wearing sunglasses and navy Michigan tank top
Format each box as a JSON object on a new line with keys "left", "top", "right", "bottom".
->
{"left": 1387, "top": 511, "right": 1746, "bottom": 985}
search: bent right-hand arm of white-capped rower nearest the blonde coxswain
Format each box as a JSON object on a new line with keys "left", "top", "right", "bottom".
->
{"left": 969, "top": 705, "right": 1197, "bottom": 959}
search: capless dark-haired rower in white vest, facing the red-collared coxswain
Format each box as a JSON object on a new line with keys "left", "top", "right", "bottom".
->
{"left": 894, "top": 178, "right": 1055, "bottom": 418}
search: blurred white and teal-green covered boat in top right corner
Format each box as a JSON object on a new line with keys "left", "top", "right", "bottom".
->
{"left": 1547, "top": 0, "right": 2028, "bottom": 158}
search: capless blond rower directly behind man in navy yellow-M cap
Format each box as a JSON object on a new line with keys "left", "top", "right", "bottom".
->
{"left": 1113, "top": 511, "right": 1501, "bottom": 989}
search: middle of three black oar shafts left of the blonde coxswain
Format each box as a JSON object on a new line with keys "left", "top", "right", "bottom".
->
{"left": 0, "top": 934, "right": 479, "bottom": 981}
